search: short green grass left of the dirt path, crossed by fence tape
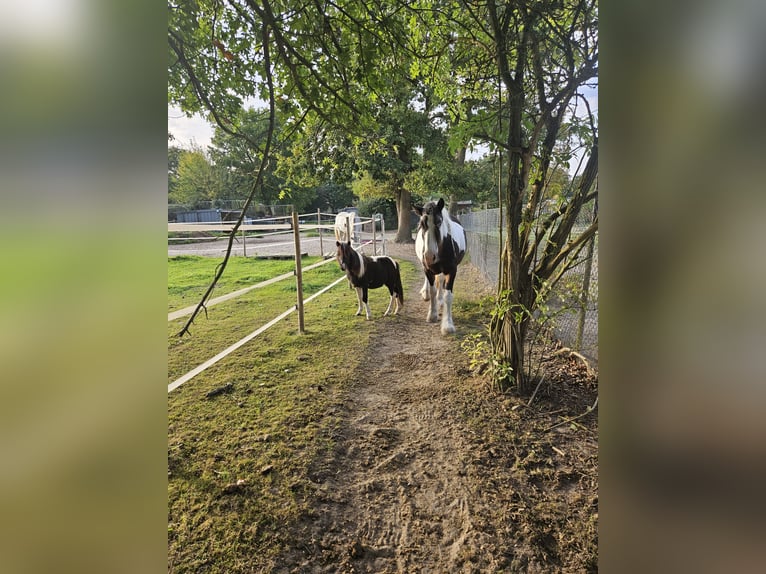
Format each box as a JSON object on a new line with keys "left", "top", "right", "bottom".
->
{"left": 168, "top": 257, "right": 416, "bottom": 573}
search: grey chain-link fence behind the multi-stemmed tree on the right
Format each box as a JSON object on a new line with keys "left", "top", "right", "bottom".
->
{"left": 460, "top": 204, "right": 598, "bottom": 368}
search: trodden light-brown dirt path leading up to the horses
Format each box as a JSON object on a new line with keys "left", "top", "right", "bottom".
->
{"left": 276, "top": 246, "right": 492, "bottom": 572}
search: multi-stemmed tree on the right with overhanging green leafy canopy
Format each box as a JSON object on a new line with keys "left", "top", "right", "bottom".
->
{"left": 168, "top": 0, "right": 598, "bottom": 392}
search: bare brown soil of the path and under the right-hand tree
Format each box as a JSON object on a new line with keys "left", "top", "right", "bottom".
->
{"left": 273, "top": 242, "right": 598, "bottom": 574}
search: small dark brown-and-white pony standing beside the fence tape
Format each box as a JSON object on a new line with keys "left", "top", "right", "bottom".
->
{"left": 335, "top": 241, "right": 404, "bottom": 321}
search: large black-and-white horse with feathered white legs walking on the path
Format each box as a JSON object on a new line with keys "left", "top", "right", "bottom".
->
{"left": 413, "top": 198, "right": 466, "bottom": 335}
